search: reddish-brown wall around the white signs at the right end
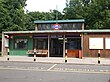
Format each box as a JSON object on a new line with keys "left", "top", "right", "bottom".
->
{"left": 83, "top": 33, "right": 110, "bottom": 58}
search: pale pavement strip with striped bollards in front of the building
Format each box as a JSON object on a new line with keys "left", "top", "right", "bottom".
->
{"left": 0, "top": 56, "right": 110, "bottom": 65}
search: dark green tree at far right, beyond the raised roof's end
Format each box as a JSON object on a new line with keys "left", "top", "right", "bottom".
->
{"left": 84, "top": 0, "right": 110, "bottom": 29}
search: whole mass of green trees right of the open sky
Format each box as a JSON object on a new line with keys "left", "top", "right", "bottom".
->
{"left": 64, "top": 0, "right": 110, "bottom": 29}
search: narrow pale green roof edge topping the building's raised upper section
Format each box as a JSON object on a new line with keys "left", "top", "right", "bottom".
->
{"left": 34, "top": 19, "right": 85, "bottom": 24}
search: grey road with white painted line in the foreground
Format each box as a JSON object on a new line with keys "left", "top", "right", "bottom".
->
{"left": 0, "top": 62, "right": 110, "bottom": 82}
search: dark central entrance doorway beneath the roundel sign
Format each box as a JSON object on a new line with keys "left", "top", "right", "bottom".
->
{"left": 50, "top": 38, "right": 63, "bottom": 57}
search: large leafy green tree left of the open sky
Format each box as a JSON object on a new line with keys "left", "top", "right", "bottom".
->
{"left": 0, "top": 0, "right": 27, "bottom": 33}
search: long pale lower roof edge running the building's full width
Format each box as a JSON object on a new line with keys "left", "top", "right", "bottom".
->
{"left": 3, "top": 30, "right": 110, "bottom": 34}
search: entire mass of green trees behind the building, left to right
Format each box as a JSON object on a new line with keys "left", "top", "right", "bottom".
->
{"left": 0, "top": 0, "right": 110, "bottom": 33}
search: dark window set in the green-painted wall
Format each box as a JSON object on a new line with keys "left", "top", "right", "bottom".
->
{"left": 14, "top": 39, "right": 28, "bottom": 49}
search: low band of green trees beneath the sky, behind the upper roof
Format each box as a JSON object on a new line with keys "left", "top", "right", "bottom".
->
{"left": 27, "top": 10, "right": 63, "bottom": 21}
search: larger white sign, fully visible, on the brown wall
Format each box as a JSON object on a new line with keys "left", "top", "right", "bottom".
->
{"left": 89, "top": 38, "right": 103, "bottom": 49}
